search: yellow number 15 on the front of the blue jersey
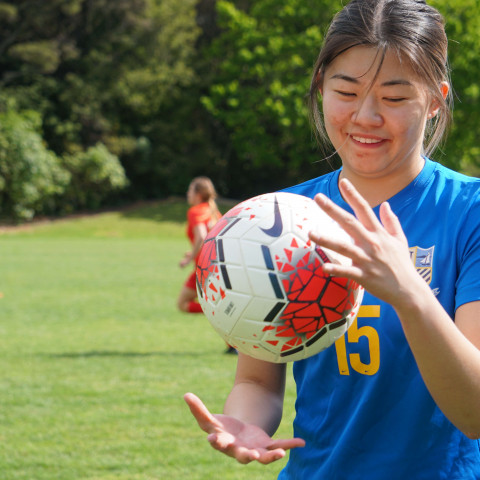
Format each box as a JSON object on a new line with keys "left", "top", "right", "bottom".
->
{"left": 335, "top": 305, "right": 380, "bottom": 375}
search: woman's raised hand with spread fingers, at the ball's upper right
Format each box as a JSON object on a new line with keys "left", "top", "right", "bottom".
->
{"left": 310, "top": 179, "right": 423, "bottom": 307}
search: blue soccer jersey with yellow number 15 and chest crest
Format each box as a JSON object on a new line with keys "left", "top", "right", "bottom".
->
{"left": 279, "top": 160, "right": 480, "bottom": 480}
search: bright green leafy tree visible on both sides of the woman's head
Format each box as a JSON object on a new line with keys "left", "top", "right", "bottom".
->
{"left": 202, "top": 0, "right": 480, "bottom": 196}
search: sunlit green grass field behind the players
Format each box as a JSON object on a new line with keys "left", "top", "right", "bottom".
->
{"left": 0, "top": 201, "right": 294, "bottom": 480}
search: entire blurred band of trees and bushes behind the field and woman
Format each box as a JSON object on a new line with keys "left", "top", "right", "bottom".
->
{"left": 0, "top": 0, "right": 480, "bottom": 222}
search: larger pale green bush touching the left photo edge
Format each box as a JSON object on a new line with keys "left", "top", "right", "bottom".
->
{"left": 0, "top": 111, "right": 70, "bottom": 220}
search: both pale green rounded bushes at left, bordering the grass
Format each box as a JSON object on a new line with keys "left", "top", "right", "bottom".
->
{"left": 0, "top": 110, "right": 128, "bottom": 221}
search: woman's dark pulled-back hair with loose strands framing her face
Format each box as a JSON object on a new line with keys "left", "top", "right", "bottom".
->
{"left": 309, "top": 0, "right": 452, "bottom": 155}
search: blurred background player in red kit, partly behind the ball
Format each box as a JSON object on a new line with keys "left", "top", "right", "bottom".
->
{"left": 177, "top": 177, "right": 221, "bottom": 313}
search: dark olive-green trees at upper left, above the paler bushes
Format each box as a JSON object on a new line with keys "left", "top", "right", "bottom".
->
{"left": 0, "top": 0, "right": 204, "bottom": 205}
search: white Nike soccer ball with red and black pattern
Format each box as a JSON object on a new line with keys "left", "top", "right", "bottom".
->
{"left": 196, "top": 192, "right": 363, "bottom": 363}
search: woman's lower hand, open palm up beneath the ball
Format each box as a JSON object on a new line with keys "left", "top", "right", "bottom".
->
{"left": 184, "top": 393, "right": 305, "bottom": 464}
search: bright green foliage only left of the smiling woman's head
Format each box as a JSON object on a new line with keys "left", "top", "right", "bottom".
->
{"left": 202, "top": 0, "right": 339, "bottom": 195}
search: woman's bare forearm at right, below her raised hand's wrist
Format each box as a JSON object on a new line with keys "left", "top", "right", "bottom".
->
{"left": 396, "top": 280, "right": 480, "bottom": 438}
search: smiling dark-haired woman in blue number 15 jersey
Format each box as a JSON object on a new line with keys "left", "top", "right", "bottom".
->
{"left": 185, "top": 0, "right": 480, "bottom": 480}
